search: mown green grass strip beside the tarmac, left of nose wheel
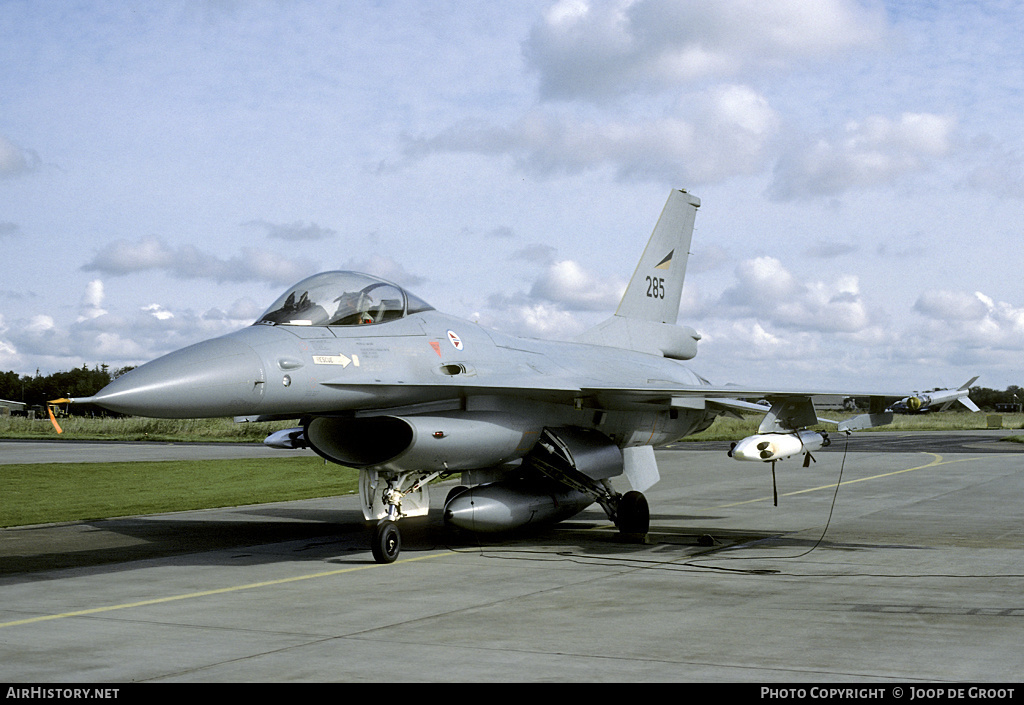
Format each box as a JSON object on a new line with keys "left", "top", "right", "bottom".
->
{"left": 0, "top": 456, "right": 358, "bottom": 527}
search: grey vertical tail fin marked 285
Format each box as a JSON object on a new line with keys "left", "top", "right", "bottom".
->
{"left": 615, "top": 190, "right": 700, "bottom": 324}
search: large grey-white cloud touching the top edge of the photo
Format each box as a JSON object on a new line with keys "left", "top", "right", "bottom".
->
{"left": 523, "top": 0, "right": 885, "bottom": 101}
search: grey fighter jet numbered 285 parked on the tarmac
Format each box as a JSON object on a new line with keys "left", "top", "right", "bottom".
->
{"left": 73, "top": 190, "right": 974, "bottom": 563}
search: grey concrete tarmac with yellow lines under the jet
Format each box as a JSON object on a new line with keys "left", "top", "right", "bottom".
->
{"left": 0, "top": 431, "right": 1024, "bottom": 683}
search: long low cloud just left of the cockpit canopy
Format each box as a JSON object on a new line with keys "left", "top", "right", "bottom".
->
{"left": 82, "top": 238, "right": 314, "bottom": 285}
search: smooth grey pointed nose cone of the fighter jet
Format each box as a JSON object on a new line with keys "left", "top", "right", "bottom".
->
{"left": 89, "top": 335, "right": 266, "bottom": 418}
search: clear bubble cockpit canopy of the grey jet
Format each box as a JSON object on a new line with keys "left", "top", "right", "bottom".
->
{"left": 256, "top": 272, "right": 433, "bottom": 326}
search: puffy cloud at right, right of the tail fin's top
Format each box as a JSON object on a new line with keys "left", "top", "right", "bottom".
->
{"left": 768, "top": 113, "right": 956, "bottom": 200}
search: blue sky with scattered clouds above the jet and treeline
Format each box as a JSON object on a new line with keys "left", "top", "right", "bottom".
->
{"left": 0, "top": 0, "right": 1024, "bottom": 389}
